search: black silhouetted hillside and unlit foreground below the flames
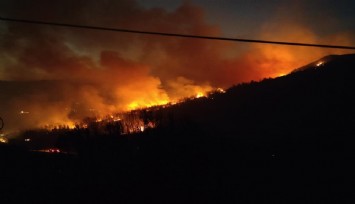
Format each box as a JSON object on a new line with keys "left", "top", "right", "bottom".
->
{"left": 0, "top": 55, "right": 355, "bottom": 203}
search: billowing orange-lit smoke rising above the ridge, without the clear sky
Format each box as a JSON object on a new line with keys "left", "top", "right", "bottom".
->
{"left": 0, "top": 0, "right": 352, "bottom": 131}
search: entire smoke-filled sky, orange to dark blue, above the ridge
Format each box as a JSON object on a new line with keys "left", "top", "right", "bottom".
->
{"left": 0, "top": 0, "right": 355, "bottom": 130}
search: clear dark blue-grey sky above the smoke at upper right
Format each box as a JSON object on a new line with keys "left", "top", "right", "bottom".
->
{"left": 138, "top": 0, "right": 355, "bottom": 37}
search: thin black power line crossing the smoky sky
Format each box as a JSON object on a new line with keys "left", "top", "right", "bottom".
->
{"left": 0, "top": 17, "right": 355, "bottom": 50}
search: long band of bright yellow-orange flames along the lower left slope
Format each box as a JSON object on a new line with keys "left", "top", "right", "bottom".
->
{"left": 12, "top": 87, "right": 226, "bottom": 134}
